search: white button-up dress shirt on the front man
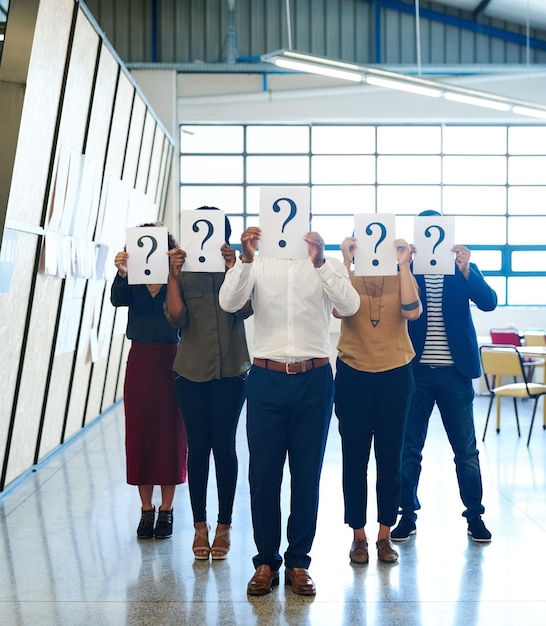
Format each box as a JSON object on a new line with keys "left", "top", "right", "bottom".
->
{"left": 220, "top": 255, "right": 360, "bottom": 363}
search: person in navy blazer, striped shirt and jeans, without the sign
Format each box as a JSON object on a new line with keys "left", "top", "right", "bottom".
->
{"left": 392, "top": 210, "right": 497, "bottom": 543}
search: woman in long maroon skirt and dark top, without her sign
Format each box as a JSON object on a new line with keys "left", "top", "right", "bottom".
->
{"left": 110, "top": 223, "right": 188, "bottom": 539}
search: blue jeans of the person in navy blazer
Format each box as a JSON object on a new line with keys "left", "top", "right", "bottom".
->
{"left": 400, "top": 364, "right": 484, "bottom": 521}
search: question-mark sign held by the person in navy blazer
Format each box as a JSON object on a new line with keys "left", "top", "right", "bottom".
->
{"left": 413, "top": 215, "right": 455, "bottom": 274}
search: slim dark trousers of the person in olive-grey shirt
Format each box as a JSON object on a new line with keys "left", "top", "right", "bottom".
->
{"left": 174, "top": 376, "right": 245, "bottom": 524}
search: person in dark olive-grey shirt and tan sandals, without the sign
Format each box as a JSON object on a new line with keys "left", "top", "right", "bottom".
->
{"left": 165, "top": 207, "right": 252, "bottom": 560}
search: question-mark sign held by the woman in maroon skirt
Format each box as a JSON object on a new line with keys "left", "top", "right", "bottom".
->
{"left": 126, "top": 226, "right": 169, "bottom": 285}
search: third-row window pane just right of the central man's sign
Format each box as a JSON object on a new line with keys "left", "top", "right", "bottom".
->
{"left": 311, "top": 185, "right": 375, "bottom": 215}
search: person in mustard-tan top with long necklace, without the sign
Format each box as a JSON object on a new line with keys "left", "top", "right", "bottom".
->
{"left": 335, "top": 237, "right": 423, "bottom": 564}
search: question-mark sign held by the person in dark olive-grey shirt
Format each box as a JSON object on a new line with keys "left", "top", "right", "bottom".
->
{"left": 180, "top": 209, "right": 226, "bottom": 272}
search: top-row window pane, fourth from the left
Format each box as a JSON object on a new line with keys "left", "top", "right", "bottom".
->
{"left": 377, "top": 126, "right": 442, "bottom": 154}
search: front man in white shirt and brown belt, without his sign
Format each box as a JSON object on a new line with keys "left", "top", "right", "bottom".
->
{"left": 220, "top": 227, "right": 360, "bottom": 595}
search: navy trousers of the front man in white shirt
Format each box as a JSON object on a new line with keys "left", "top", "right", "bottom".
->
{"left": 247, "top": 364, "right": 333, "bottom": 571}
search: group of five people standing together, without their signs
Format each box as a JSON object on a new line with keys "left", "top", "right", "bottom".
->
{"left": 111, "top": 207, "right": 496, "bottom": 595}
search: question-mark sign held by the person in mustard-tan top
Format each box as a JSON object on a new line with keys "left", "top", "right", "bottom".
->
{"left": 355, "top": 213, "right": 397, "bottom": 276}
